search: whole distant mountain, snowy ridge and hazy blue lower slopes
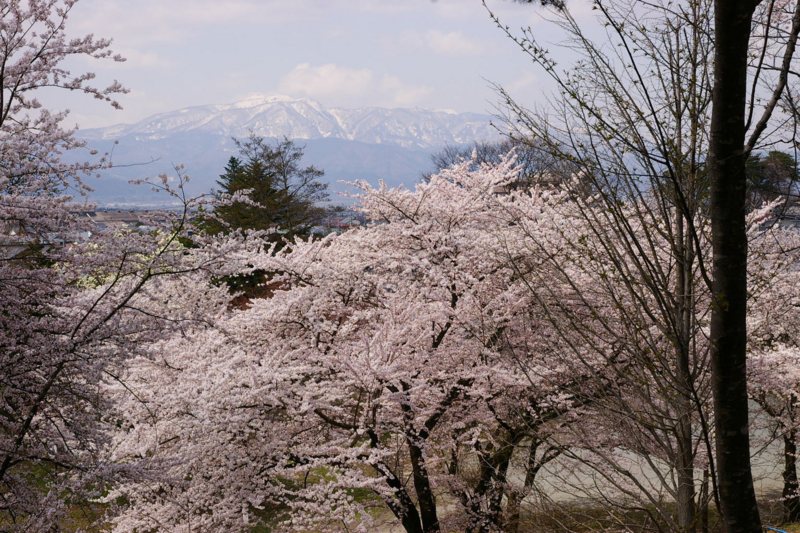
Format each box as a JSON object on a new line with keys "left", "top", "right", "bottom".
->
{"left": 78, "top": 97, "right": 498, "bottom": 205}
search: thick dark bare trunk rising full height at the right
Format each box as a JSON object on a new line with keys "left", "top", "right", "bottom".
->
{"left": 708, "top": 0, "right": 762, "bottom": 533}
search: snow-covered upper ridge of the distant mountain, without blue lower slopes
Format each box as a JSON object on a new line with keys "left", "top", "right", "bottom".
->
{"left": 80, "top": 95, "right": 498, "bottom": 149}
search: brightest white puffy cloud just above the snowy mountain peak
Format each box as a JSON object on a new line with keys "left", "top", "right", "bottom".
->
{"left": 279, "top": 63, "right": 431, "bottom": 107}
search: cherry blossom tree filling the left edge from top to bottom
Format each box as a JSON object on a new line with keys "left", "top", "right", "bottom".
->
{"left": 0, "top": 0, "right": 262, "bottom": 532}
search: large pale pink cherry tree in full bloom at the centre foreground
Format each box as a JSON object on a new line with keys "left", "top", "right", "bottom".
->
{"left": 110, "top": 161, "right": 581, "bottom": 532}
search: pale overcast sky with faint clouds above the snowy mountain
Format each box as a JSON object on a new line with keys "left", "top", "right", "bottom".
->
{"left": 42, "top": 0, "right": 588, "bottom": 128}
